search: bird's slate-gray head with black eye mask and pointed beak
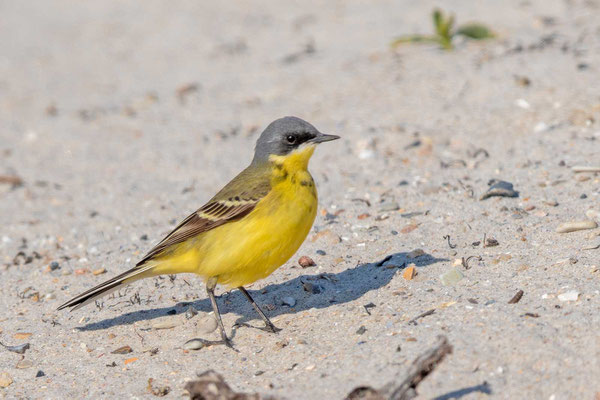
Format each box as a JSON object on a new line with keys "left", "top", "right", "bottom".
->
{"left": 253, "top": 117, "right": 339, "bottom": 162}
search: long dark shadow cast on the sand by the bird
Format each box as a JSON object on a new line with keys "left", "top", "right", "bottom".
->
{"left": 78, "top": 253, "right": 448, "bottom": 331}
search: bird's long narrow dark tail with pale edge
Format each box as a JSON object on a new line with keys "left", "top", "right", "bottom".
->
{"left": 58, "top": 262, "right": 157, "bottom": 311}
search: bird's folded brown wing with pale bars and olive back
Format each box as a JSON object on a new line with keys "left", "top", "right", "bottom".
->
{"left": 137, "top": 169, "right": 271, "bottom": 266}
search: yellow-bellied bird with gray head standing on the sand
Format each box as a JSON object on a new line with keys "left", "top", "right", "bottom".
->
{"left": 58, "top": 116, "right": 340, "bottom": 347}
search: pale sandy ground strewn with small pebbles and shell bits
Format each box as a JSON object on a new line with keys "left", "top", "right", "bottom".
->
{"left": 0, "top": 0, "right": 600, "bottom": 399}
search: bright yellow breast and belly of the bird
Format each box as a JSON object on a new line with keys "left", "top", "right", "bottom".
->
{"left": 152, "top": 170, "right": 317, "bottom": 287}
